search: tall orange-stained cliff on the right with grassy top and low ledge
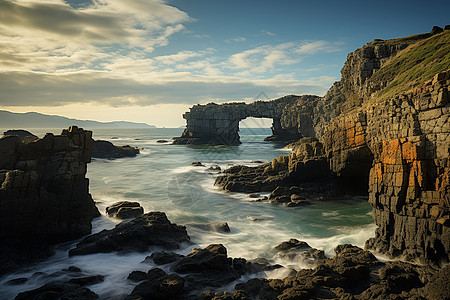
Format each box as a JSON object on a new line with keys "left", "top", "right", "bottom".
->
{"left": 216, "top": 30, "right": 450, "bottom": 262}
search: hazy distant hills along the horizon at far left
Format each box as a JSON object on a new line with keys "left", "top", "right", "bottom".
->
{"left": 0, "top": 110, "right": 156, "bottom": 129}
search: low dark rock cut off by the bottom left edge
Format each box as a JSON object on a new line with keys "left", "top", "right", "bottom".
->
{"left": 15, "top": 283, "right": 98, "bottom": 300}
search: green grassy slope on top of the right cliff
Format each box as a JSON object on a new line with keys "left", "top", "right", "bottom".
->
{"left": 369, "top": 30, "right": 450, "bottom": 100}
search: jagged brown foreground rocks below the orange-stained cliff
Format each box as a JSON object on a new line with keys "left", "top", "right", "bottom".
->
{"left": 202, "top": 244, "right": 450, "bottom": 300}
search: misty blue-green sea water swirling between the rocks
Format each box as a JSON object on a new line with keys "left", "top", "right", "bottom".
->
{"left": 0, "top": 128, "right": 376, "bottom": 299}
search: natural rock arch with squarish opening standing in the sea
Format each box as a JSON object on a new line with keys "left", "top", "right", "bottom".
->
{"left": 173, "top": 95, "right": 318, "bottom": 145}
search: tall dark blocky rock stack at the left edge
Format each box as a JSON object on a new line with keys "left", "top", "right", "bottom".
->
{"left": 0, "top": 126, "right": 99, "bottom": 272}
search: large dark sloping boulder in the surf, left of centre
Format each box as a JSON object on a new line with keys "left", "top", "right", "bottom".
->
{"left": 69, "top": 212, "right": 190, "bottom": 256}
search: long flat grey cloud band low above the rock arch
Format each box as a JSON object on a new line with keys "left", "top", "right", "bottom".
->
{"left": 0, "top": 71, "right": 327, "bottom": 107}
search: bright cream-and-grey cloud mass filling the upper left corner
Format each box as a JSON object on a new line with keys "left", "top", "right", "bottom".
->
{"left": 0, "top": 0, "right": 192, "bottom": 72}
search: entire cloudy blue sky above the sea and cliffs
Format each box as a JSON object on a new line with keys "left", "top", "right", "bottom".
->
{"left": 0, "top": 0, "right": 450, "bottom": 127}
